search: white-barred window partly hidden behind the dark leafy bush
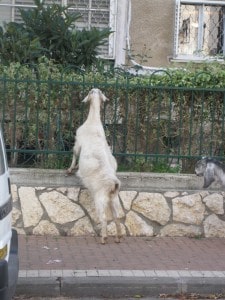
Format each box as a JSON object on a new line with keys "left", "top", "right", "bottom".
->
{"left": 0, "top": 0, "right": 117, "bottom": 59}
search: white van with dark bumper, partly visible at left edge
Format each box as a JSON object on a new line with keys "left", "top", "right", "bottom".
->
{"left": 0, "top": 126, "right": 19, "bottom": 300}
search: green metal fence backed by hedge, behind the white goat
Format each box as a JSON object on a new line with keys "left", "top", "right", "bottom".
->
{"left": 0, "top": 67, "right": 225, "bottom": 172}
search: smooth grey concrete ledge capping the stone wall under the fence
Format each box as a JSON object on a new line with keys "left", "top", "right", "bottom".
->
{"left": 10, "top": 168, "right": 209, "bottom": 191}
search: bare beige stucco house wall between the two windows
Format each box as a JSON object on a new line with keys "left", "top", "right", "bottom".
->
{"left": 129, "top": 0, "right": 175, "bottom": 67}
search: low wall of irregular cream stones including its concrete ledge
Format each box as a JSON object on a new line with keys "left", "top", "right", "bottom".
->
{"left": 10, "top": 169, "right": 225, "bottom": 237}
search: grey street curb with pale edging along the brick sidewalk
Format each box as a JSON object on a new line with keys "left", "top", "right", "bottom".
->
{"left": 16, "top": 270, "right": 225, "bottom": 299}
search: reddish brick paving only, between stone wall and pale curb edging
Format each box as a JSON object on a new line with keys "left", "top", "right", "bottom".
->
{"left": 19, "top": 235, "right": 225, "bottom": 274}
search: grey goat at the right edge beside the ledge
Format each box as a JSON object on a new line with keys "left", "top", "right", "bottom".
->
{"left": 195, "top": 157, "right": 225, "bottom": 188}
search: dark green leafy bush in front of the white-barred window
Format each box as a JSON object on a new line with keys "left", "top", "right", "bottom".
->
{"left": 0, "top": 0, "right": 111, "bottom": 68}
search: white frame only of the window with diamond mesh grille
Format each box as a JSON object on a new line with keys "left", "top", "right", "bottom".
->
{"left": 173, "top": 0, "right": 225, "bottom": 61}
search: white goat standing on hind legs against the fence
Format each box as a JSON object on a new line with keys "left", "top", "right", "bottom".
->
{"left": 67, "top": 89, "right": 121, "bottom": 244}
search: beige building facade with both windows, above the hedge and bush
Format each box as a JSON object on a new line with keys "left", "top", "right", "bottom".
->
{"left": 0, "top": 0, "right": 225, "bottom": 69}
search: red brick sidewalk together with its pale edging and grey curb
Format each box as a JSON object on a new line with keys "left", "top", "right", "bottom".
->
{"left": 16, "top": 235, "right": 225, "bottom": 299}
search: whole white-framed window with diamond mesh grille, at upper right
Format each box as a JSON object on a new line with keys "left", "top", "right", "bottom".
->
{"left": 174, "top": 0, "right": 225, "bottom": 60}
